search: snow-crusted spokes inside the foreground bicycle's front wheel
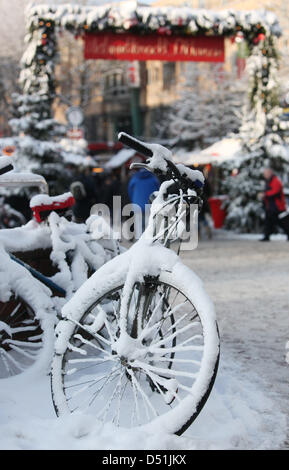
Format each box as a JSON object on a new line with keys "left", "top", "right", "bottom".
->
{"left": 59, "top": 282, "right": 203, "bottom": 426}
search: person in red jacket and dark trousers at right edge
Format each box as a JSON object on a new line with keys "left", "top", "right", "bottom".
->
{"left": 261, "top": 168, "right": 289, "bottom": 241}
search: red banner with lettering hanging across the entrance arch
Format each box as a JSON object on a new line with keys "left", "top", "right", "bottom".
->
{"left": 84, "top": 33, "right": 225, "bottom": 62}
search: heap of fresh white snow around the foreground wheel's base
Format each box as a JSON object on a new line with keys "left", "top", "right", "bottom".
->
{"left": 0, "top": 354, "right": 286, "bottom": 451}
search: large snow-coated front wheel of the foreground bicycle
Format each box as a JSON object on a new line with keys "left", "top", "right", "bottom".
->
{"left": 51, "top": 265, "right": 219, "bottom": 434}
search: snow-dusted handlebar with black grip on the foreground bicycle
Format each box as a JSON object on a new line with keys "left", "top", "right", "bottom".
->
{"left": 118, "top": 132, "right": 205, "bottom": 189}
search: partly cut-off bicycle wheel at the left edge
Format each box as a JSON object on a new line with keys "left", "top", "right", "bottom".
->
{"left": 0, "top": 296, "right": 43, "bottom": 378}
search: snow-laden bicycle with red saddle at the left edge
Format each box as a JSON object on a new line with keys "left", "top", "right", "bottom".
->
{"left": 0, "top": 158, "right": 120, "bottom": 378}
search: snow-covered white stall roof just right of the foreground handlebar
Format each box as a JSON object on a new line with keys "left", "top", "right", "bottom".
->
{"left": 173, "top": 138, "right": 241, "bottom": 165}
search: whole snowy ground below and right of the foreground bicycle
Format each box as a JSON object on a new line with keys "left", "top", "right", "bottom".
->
{"left": 0, "top": 233, "right": 289, "bottom": 450}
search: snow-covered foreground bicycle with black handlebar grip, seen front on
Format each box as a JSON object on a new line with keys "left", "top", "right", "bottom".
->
{"left": 51, "top": 133, "right": 219, "bottom": 434}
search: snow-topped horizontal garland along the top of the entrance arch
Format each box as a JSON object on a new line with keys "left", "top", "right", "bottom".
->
{"left": 27, "top": 4, "right": 281, "bottom": 37}
